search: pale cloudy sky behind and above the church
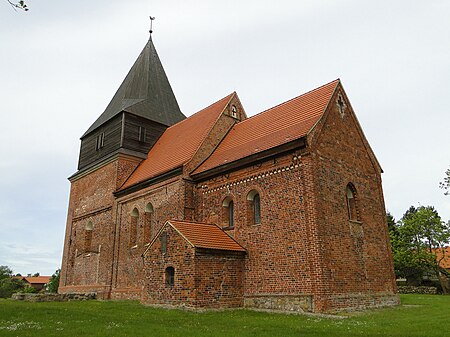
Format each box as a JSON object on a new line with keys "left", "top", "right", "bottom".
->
{"left": 0, "top": 0, "right": 450, "bottom": 275}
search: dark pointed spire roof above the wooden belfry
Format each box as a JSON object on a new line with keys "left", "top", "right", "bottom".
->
{"left": 82, "top": 36, "right": 186, "bottom": 138}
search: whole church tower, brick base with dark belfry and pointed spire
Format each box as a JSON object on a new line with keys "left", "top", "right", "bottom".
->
{"left": 60, "top": 36, "right": 186, "bottom": 298}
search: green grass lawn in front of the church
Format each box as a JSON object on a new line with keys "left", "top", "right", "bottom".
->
{"left": 0, "top": 295, "right": 450, "bottom": 337}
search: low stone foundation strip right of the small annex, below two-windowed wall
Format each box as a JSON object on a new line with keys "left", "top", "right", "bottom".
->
{"left": 244, "top": 294, "right": 314, "bottom": 312}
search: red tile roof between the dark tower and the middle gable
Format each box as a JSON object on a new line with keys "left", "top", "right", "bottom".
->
{"left": 121, "top": 93, "right": 235, "bottom": 189}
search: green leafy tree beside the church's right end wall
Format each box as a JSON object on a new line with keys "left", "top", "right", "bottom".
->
{"left": 388, "top": 206, "right": 450, "bottom": 285}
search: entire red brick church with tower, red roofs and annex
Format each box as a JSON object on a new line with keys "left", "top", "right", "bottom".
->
{"left": 59, "top": 38, "right": 398, "bottom": 312}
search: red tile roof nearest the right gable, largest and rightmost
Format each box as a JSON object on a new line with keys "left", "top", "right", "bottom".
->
{"left": 193, "top": 80, "right": 339, "bottom": 174}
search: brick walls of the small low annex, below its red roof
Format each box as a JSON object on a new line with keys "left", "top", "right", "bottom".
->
{"left": 142, "top": 226, "right": 244, "bottom": 308}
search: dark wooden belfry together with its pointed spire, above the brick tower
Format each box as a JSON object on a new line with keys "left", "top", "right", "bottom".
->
{"left": 77, "top": 37, "right": 186, "bottom": 173}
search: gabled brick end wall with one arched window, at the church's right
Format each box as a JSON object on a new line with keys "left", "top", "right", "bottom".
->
{"left": 309, "top": 86, "right": 398, "bottom": 310}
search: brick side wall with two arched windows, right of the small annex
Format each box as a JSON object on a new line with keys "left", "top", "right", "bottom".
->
{"left": 197, "top": 153, "right": 317, "bottom": 295}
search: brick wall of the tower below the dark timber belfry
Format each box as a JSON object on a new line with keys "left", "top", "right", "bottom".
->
{"left": 59, "top": 156, "right": 138, "bottom": 297}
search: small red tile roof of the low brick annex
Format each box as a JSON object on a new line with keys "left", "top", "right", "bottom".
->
{"left": 168, "top": 220, "right": 245, "bottom": 252}
